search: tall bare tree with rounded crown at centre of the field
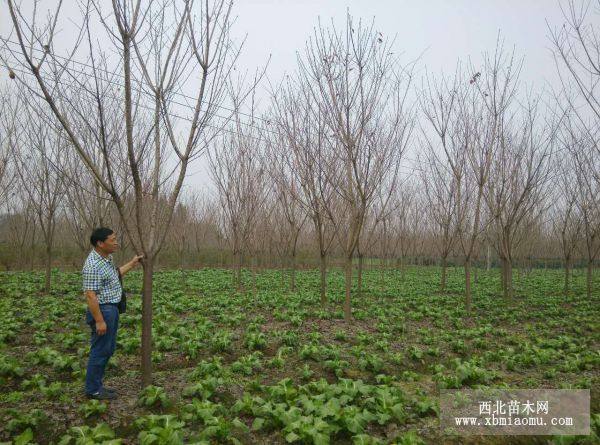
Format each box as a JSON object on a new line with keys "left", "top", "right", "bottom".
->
{"left": 299, "top": 15, "right": 412, "bottom": 321}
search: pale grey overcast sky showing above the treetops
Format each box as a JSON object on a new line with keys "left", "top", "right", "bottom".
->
{"left": 0, "top": 0, "right": 576, "bottom": 193}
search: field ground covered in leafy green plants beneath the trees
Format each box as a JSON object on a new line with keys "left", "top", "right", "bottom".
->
{"left": 0, "top": 267, "right": 600, "bottom": 445}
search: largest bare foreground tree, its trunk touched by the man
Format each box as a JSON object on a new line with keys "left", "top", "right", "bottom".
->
{"left": 2, "top": 0, "right": 246, "bottom": 386}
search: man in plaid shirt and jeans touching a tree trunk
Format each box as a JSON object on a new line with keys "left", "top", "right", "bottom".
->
{"left": 82, "top": 227, "right": 142, "bottom": 400}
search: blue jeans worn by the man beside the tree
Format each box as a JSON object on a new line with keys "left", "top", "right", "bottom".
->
{"left": 85, "top": 304, "right": 119, "bottom": 394}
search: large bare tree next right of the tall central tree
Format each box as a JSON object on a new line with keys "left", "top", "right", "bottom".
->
{"left": 421, "top": 42, "right": 521, "bottom": 314}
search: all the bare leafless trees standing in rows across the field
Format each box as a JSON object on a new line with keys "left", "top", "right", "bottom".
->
{"left": 0, "top": 0, "right": 600, "bottom": 384}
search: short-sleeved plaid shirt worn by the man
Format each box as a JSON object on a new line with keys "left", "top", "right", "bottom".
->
{"left": 82, "top": 249, "right": 122, "bottom": 304}
